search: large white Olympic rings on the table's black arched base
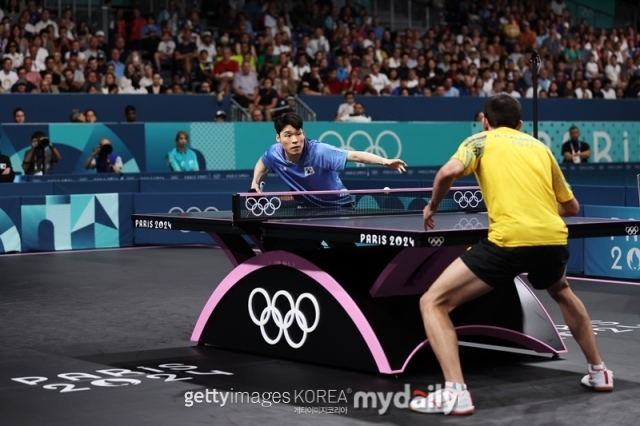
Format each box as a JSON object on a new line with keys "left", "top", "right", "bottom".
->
{"left": 248, "top": 288, "right": 320, "bottom": 349}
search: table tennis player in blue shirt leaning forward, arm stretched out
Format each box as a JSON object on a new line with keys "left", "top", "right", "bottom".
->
{"left": 251, "top": 112, "right": 407, "bottom": 207}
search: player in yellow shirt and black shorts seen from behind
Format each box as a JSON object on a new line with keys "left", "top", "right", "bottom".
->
{"left": 410, "top": 94, "right": 613, "bottom": 415}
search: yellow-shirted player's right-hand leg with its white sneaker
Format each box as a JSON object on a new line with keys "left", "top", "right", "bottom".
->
{"left": 547, "top": 275, "right": 613, "bottom": 392}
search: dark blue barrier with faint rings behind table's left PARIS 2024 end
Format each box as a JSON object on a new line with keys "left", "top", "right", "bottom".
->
{"left": 133, "top": 193, "right": 231, "bottom": 245}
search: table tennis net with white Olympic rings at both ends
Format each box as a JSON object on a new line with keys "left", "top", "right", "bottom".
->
{"left": 233, "top": 187, "right": 486, "bottom": 220}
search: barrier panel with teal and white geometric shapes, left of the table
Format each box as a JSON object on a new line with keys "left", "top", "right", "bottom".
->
{"left": 21, "top": 194, "right": 133, "bottom": 252}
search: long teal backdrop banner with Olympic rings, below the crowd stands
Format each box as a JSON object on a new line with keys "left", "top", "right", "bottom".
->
{"left": 0, "top": 121, "right": 640, "bottom": 175}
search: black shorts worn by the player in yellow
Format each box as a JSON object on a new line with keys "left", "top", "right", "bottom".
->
{"left": 460, "top": 239, "right": 569, "bottom": 290}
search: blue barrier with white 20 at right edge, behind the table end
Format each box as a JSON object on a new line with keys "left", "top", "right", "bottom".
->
{"left": 584, "top": 206, "right": 640, "bottom": 280}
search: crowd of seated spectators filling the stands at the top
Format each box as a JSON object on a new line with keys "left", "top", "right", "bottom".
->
{"left": 0, "top": 0, "right": 640, "bottom": 116}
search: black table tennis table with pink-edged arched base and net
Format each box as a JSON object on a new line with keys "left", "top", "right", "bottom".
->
{"left": 132, "top": 187, "right": 640, "bottom": 374}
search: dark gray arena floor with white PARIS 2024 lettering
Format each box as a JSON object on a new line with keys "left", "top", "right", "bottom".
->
{"left": 0, "top": 248, "right": 640, "bottom": 426}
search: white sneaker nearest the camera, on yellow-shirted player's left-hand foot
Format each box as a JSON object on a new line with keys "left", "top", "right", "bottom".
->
{"left": 409, "top": 388, "right": 474, "bottom": 416}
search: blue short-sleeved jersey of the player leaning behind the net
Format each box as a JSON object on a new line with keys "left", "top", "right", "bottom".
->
{"left": 262, "top": 140, "right": 353, "bottom": 207}
